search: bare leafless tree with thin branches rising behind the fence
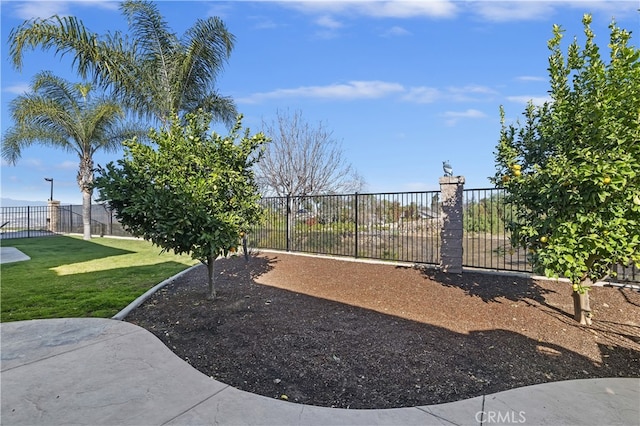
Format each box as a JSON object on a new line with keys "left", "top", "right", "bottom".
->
{"left": 256, "top": 110, "right": 364, "bottom": 197}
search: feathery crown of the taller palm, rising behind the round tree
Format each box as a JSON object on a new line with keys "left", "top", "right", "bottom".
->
{"left": 9, "top": 0, "right": 237, "bottom": 126}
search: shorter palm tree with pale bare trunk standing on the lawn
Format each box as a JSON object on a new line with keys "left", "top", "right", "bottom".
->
{"left": 2, "top": 71, "right": 145, "bottom": 240}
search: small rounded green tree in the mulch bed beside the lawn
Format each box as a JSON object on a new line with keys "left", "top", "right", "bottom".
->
{"left": 96, "top": 112, "right": 267, "bottom": 299}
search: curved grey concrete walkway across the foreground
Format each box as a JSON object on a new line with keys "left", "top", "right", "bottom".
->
{"left": 0, "top": 318, "right": 640, "bottom": 425}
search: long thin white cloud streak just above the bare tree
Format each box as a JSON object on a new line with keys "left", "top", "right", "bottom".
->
{"left": 237, "top": 81, "right": 404, "bottom": 103}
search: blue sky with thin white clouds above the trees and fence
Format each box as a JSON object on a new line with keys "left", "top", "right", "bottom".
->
{"left": 0, "top": 0, "right": 640, "bottom": 204}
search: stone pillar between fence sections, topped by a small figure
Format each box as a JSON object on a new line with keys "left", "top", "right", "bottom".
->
{"left": 440, "top": 176, "right": 464, "bottom": 274}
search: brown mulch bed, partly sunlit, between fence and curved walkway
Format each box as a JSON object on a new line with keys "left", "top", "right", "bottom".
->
{"left": 126, "top": 253, "right": 640, "bottom": 408}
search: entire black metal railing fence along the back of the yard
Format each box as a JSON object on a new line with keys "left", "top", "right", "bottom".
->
{"left": 0, "top": 192, "right": 640, "bottom": 283}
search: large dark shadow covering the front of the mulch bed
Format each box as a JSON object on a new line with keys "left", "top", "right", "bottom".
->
{"left": 127, "top": 258, "right": 640, "bottom": 410}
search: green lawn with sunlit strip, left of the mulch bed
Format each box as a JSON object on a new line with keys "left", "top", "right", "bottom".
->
{"left": 0, "top": 236, "right": 198, "bottom": 322}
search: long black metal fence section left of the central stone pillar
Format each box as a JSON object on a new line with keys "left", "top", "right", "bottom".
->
{"left": 250, "top": 191, "right": 441, "bottom": 264}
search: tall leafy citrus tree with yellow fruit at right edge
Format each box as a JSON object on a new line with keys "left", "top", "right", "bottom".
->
{"left": 494, "top": 15, "right": 640, "bottom": 324}
